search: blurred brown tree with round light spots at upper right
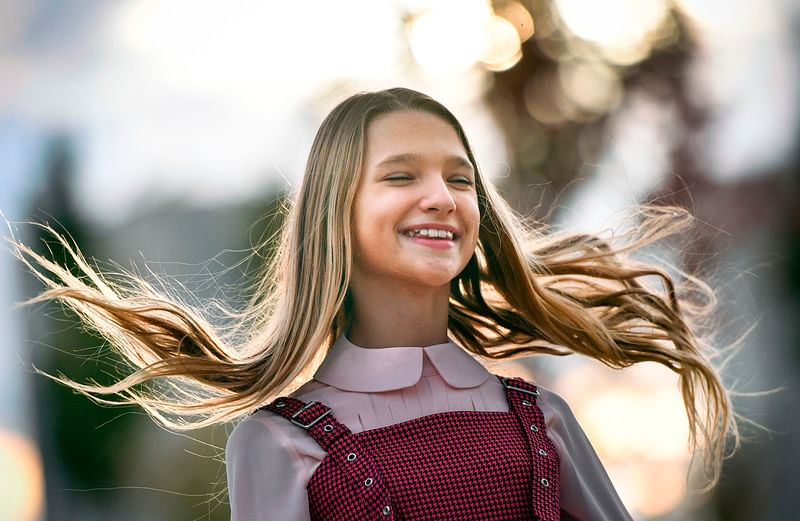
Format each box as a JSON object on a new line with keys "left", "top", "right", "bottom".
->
{"left": 485, "top": 0, "right": 706, "bottom": 219}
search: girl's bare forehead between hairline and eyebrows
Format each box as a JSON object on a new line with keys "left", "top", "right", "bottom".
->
{"left": 365, "top": 111, "right": 466, "bottom": 164}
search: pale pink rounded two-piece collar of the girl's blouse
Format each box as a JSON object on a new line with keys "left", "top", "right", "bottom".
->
{"left": 314, "top": 335, "right": 491, "bottom": 392}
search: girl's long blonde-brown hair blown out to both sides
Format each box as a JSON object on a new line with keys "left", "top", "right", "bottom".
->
{"left": 9, "top": 88, "right": 738, "bottom": 486}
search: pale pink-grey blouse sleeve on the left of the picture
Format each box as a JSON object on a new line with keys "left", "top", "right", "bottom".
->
{"left": 225, "top": 416, "right": 310, "bottom": 521}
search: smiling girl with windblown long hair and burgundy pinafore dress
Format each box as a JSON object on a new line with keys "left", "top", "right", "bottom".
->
{"left": 14, "top": 88, "right": 736, "bottom": 521}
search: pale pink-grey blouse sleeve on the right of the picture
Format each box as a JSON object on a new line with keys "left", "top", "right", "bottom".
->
{"left": 539, "top": 387, "right": 633, "bottom": 521}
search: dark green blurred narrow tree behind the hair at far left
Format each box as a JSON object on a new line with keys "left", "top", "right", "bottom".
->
{"left": 28, "top": 135, "right": 136, "bottom": 519}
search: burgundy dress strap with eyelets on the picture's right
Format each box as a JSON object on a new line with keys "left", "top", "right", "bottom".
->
{"left": 498, "top": 376, "right": 561, "bottom": 521}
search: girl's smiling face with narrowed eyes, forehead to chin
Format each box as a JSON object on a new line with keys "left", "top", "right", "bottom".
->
{"left": 353, "top": 111, "right": 480, "bottom": 286}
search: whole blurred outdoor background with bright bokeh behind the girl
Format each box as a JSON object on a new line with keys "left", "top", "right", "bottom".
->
{"left": 0, "top": 0, "right": 800, "bottom": 521}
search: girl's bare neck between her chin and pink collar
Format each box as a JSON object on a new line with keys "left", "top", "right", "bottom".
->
{"left": 347, "top": 281, "right": 450, "bottom": 347}
